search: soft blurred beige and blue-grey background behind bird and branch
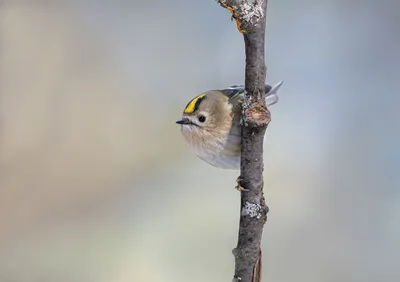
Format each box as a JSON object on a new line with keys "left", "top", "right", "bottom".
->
{"left": 0, "top": 0, "right": 400, "bottom": 282}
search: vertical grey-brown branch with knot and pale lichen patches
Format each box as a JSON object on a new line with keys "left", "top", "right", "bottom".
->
{"left": 218, "top": 0, "right": 271, "bottom": 282}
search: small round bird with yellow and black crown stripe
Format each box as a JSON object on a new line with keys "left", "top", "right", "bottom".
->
{"left": 176, "top": 81, "right": 283, "bottom": 170}
